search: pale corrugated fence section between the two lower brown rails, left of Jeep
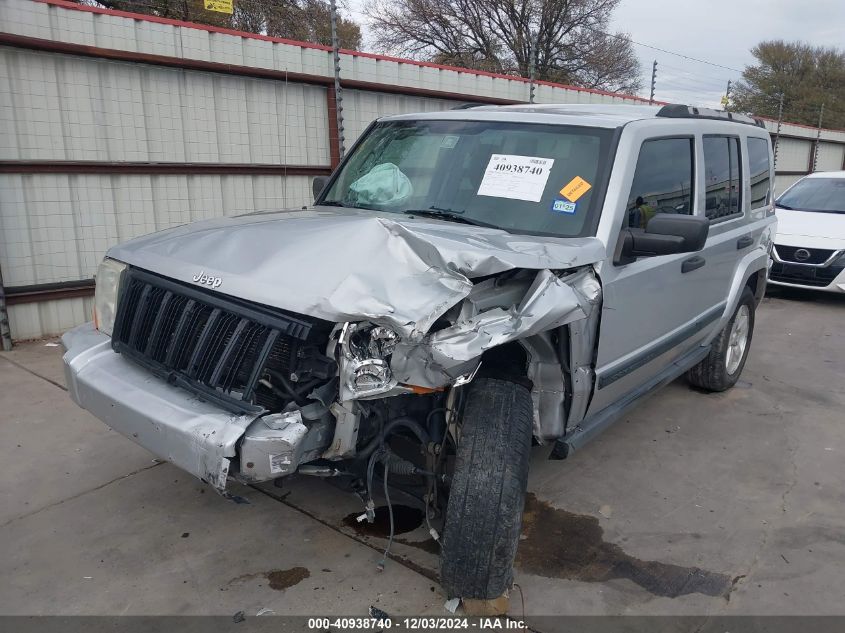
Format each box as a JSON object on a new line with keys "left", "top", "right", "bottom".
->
{"left": 0, "top": 174, "right": 311, "bottom": 286}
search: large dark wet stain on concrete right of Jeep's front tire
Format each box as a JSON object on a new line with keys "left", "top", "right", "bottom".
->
{"left": 516, "top": 493, "right": 732, "bottom": 598}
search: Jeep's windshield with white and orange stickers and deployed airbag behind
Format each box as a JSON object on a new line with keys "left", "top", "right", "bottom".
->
{"left": 319, "top": 121, "right": 613, "bottom": 237}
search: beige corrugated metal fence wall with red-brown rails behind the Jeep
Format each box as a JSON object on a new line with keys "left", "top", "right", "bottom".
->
{"left": 0, "top": 0, "right": 845, "bottom": 339}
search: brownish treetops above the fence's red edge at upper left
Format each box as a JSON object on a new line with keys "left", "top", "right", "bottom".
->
{"left": 75, "top": 0, "right": 361, "bottom": 50}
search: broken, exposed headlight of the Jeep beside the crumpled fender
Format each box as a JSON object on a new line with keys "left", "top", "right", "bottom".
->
{"left": 342, "top": 323, "right": 399, "bottom": 397}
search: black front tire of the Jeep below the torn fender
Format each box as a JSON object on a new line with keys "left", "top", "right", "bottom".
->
{"left": 440, "top": 378, "right": 533, "bottom": 600}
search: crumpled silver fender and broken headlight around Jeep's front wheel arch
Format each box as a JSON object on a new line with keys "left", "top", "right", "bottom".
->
{"left": 324, "top": 266, "right": 601, "bottom": 458}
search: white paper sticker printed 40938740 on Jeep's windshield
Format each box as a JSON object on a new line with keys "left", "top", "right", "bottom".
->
{"left": 478, "top": 154, "right": 555, "bottom": 202}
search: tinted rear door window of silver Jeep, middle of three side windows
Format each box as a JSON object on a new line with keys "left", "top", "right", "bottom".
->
{"left": 703, "top": 136, "right": 742, "bottom": 221}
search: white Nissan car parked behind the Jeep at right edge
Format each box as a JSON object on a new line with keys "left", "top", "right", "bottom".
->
{"left": 769, "top": 171, "right": 845, "bottom": 292}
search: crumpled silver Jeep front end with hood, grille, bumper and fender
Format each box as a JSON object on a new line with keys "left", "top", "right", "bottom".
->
{"left": 64, "top": 210, "right": 604, "bottom": 491}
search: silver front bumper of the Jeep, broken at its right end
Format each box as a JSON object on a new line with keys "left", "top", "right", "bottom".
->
{"left": 62, "top": 323, "right": 320, "bottom": 492}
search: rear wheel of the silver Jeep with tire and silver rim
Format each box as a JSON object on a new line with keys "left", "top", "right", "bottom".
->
{"left": 687, "top": 286, "right": 756, "bottom": 391}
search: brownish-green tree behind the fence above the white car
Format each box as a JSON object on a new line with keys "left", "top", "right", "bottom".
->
{"left": 730, "top": 40, "right": 845, "bottom": 128}
